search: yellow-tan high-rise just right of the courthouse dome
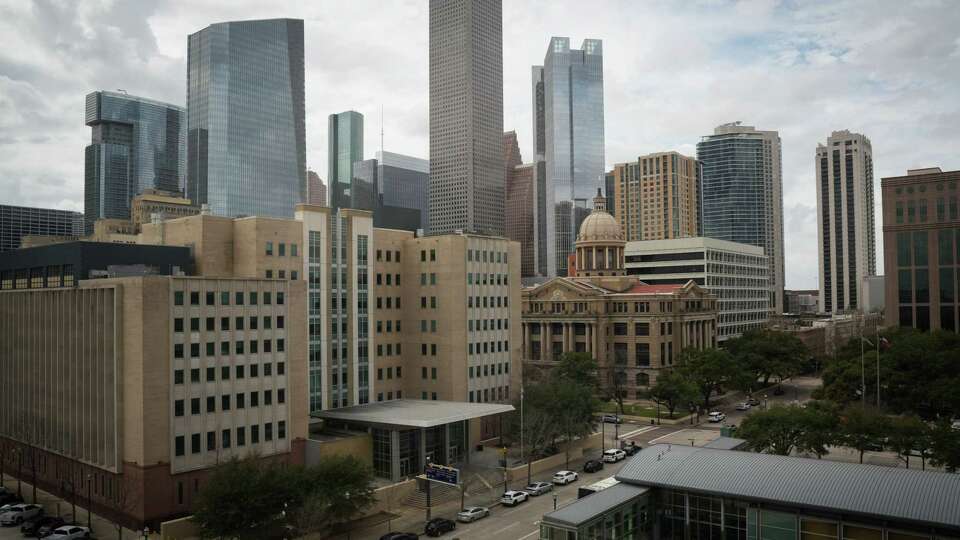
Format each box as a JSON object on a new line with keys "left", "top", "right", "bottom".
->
{"left": 607, "top": 152, "right": 700, "bottom": 242}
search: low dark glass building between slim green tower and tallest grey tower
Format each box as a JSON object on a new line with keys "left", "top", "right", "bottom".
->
{"left": 351, "top": 152, "right": 430, "bottom": 232}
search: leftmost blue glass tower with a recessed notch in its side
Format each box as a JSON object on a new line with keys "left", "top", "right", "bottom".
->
{"left": 84, "top": 91, "right": 186, "bottom": 234}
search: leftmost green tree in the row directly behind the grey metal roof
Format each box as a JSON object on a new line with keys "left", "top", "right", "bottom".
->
{"left": 737, "top": 406, "right": 807, "bottom": 456}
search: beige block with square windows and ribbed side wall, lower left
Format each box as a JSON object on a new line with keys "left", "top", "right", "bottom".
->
{"left": 0, "top": 276, "right": 307, "bottom": 530}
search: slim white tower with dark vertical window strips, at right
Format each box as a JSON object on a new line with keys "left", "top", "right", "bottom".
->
{"left": 816, "top": 130, "right": 877, "bottom": 313}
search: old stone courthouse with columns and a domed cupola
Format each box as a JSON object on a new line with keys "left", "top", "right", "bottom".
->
{"left": 521, "top": 192, "right": 717, "bottom": 392}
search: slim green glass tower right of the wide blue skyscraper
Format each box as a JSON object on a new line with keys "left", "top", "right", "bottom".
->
{"left": 327, "top": 111, "right": 364, "bottom": 210}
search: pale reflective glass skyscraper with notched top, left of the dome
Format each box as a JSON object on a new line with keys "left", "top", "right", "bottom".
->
{"left": 532, "top": 37, "right": 606, "bottom": 275}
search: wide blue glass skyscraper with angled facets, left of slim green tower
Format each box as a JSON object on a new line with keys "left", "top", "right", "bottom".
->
{"left": 187, "top": 19, "right": 307, "bottom": 217}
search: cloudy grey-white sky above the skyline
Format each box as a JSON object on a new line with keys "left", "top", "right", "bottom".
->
{"left": 0, "top": 0, "right": 960, "bottom": 289}
